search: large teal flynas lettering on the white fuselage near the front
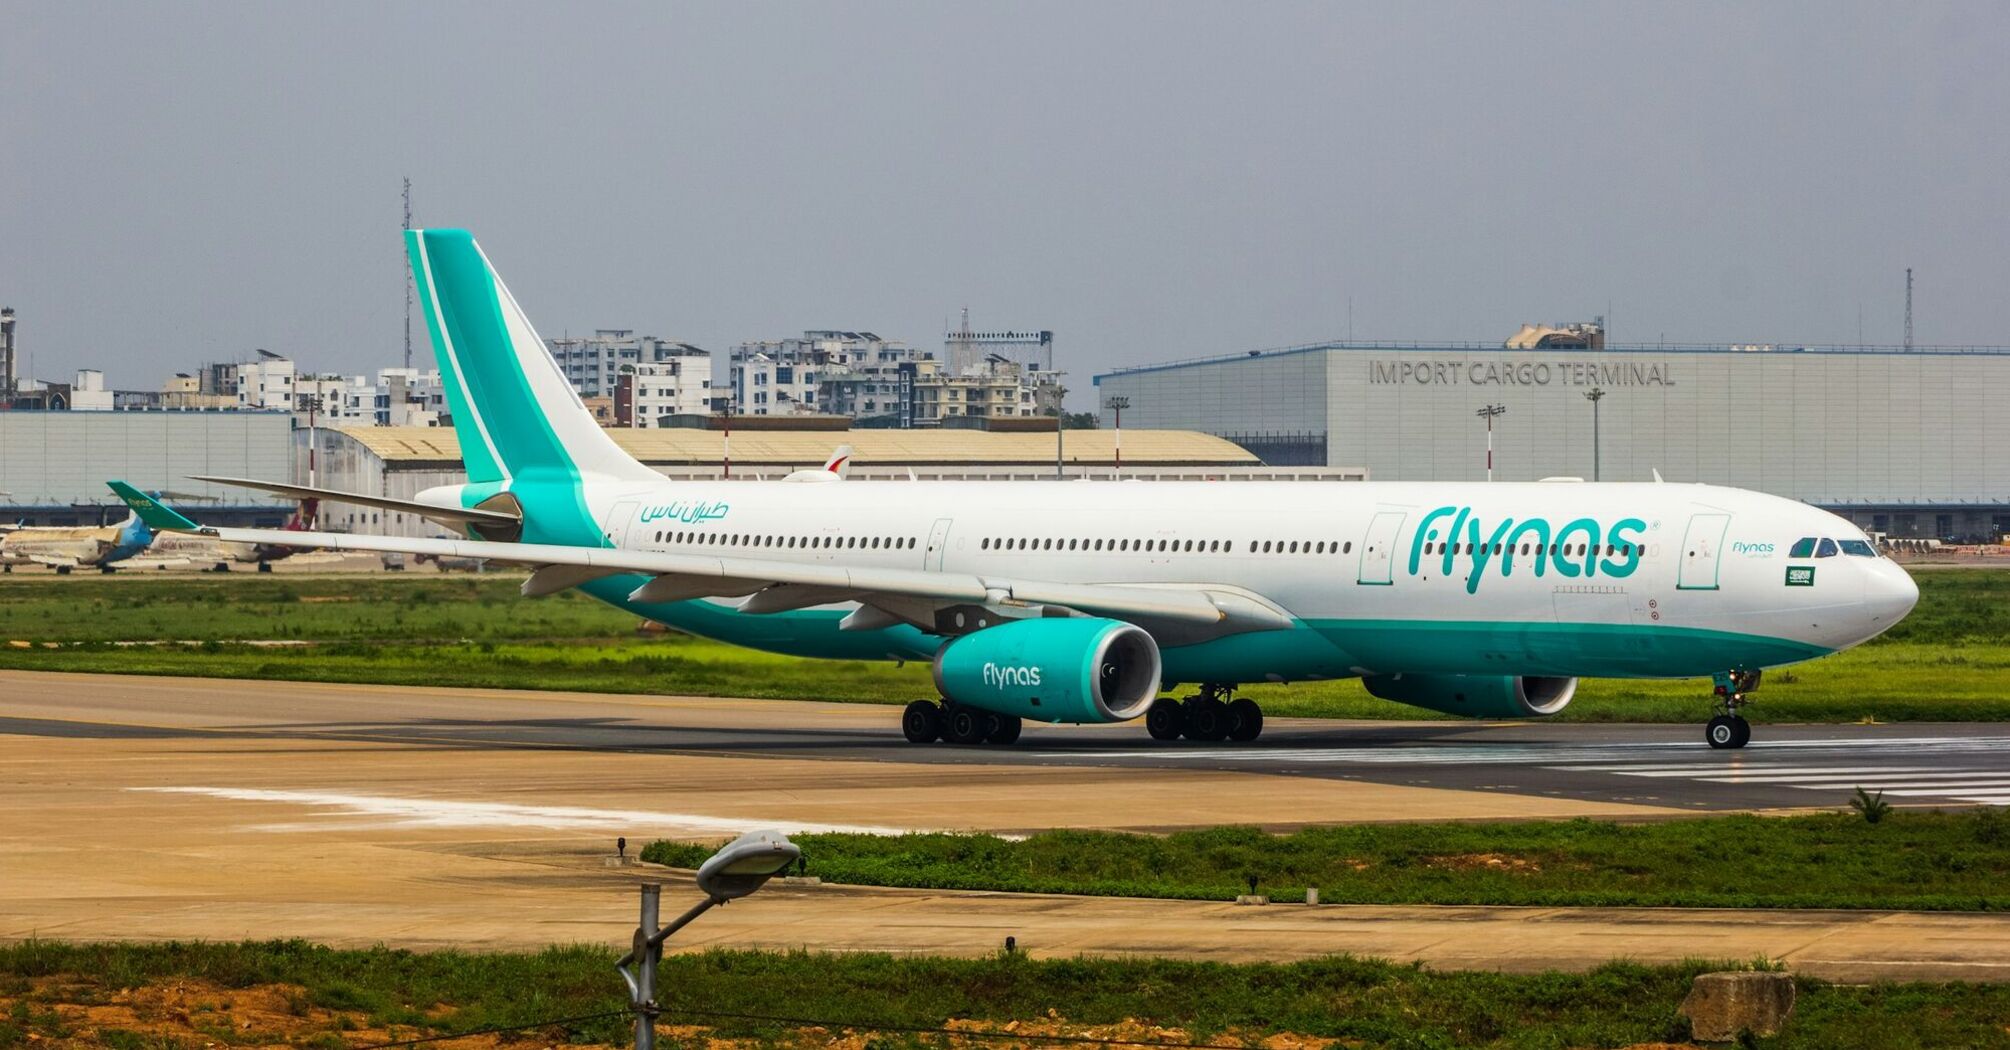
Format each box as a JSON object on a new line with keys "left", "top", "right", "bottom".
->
{"left": 1409, "top": 507, "right": 1646, "bottom": 593}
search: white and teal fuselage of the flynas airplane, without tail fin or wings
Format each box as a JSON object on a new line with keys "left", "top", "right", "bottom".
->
{"left": 514, "top": 481, "right": 1918, "bottom": 682}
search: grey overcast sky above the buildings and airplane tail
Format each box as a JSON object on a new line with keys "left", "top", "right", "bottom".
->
{"left": 0, "top": 0, "right": 2010, "bottom": 396}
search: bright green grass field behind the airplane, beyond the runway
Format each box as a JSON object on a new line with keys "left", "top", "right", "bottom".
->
{"left": 0, "top": 569, "right": 2010, "bottom": 722}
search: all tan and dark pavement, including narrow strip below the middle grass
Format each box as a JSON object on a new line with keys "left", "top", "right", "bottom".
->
{"left": 11, "top": 672, "right": 2010, "bottom": 980}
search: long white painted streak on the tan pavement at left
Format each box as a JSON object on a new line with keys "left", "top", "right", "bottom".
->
{"left": 141, "top": 786, "right": 911, "bottom": 835}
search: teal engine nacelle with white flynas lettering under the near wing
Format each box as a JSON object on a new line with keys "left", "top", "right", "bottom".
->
{"left": 935, "top": 618, "right": 1160, "bottom": 722}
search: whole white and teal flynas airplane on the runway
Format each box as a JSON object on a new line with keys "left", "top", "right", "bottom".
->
{"left": 113, "top": 229, "right": 1920, "bottom": 748}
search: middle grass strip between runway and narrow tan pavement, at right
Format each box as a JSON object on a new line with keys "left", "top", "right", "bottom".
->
{"left": 643, "top": 811, "right": 2010, "bottom": 911}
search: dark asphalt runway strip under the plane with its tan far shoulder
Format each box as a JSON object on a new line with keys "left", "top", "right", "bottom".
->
{"left": 0, "top": 672, "right": 2010, "bottom": 812}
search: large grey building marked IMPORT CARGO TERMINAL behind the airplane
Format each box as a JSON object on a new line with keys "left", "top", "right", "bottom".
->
{"left": 1095, "top": 339, "right": 2010, "bottom": 541}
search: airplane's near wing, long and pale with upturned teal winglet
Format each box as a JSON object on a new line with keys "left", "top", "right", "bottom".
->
{"left": 111, "top": 481, "right": 1290, "bottom": 640}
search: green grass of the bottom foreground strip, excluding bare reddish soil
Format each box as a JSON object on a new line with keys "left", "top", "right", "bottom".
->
{"left": 0, "top": 941, "right": 2010, "bottom": 1050}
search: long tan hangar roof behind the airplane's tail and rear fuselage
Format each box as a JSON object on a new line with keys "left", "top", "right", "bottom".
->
{"left": 342, "top": 426, "right": 1258, "bottom": 467}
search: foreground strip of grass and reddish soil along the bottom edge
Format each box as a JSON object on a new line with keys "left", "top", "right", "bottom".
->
{"left": 0, "top": 943, "right": 2010, "bottom": 1050}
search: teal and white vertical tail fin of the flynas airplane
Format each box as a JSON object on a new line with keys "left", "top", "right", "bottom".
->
{"left": 404, "top": 229, "right": 661, "bottom": 489}
